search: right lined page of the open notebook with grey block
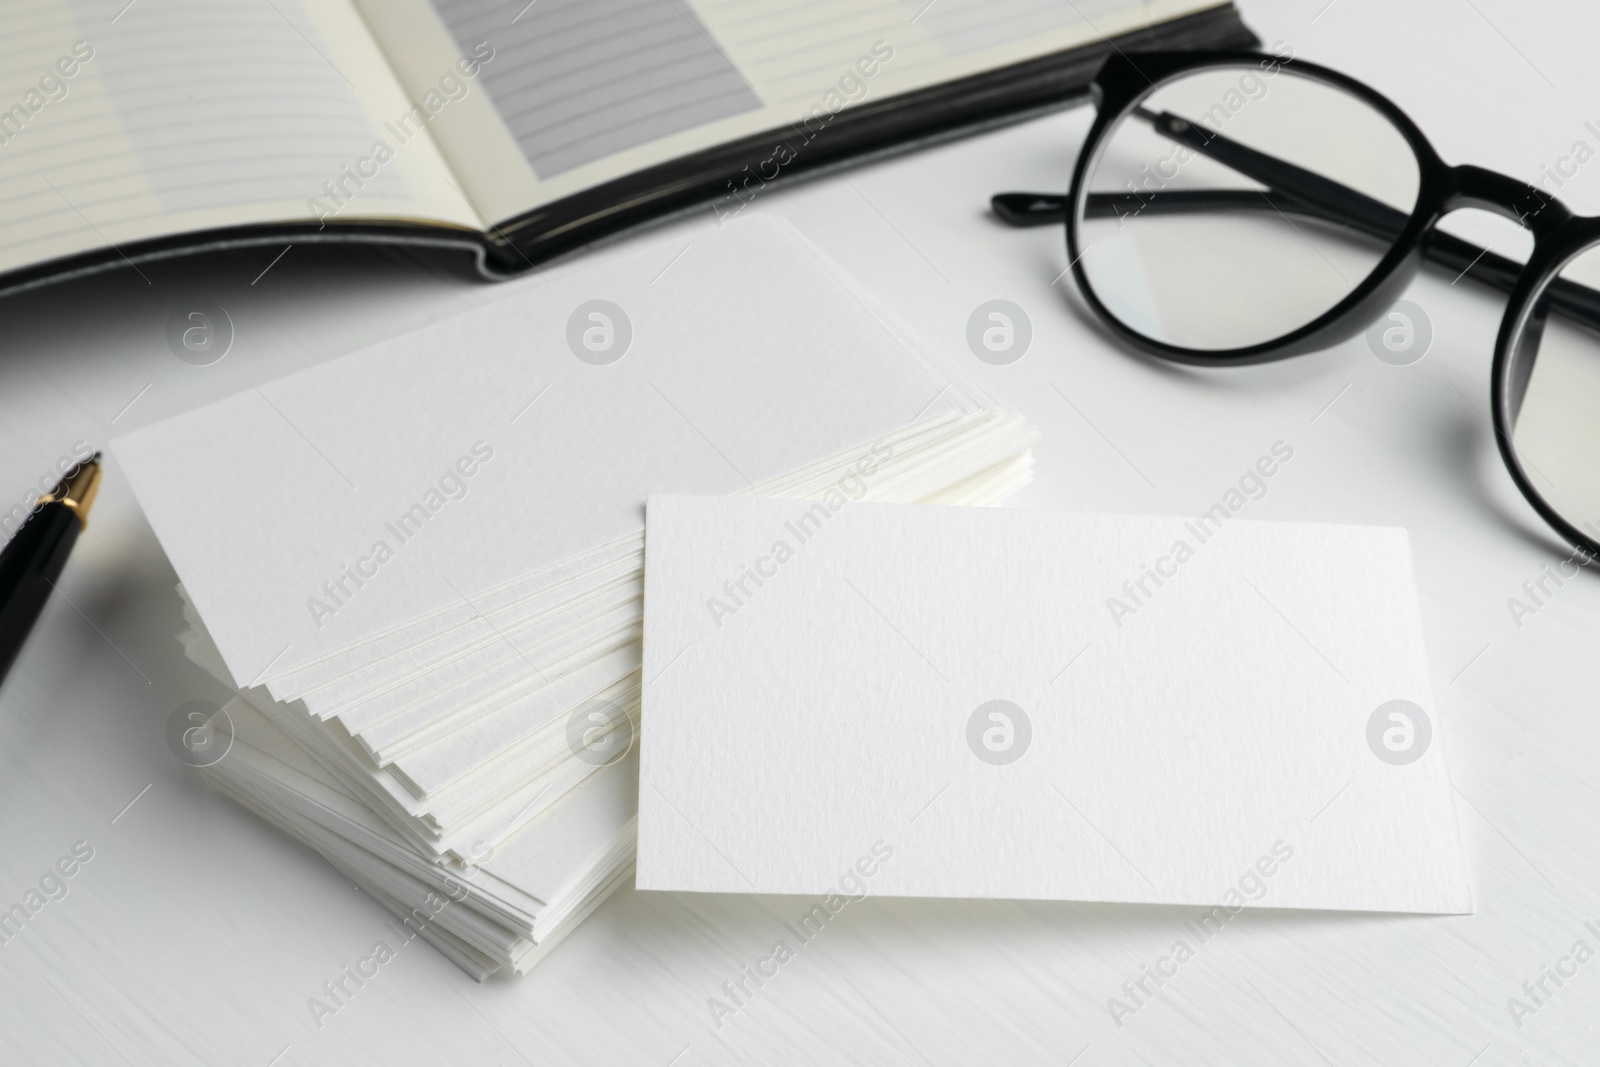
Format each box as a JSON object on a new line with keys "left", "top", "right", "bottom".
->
{"left": 357, "top": 0, "right": 1218, "bottom": 221}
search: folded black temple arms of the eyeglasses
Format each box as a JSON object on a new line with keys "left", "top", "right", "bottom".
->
{"left": 990, "top": 107, "right": 1600, "bottom": 330}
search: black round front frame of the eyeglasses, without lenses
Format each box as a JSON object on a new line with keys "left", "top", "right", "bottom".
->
{"left": 1036, "top": 51, "right": 1600, "bottom": 557}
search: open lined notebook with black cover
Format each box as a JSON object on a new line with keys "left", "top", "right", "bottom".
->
{"left": 0, "top": 0, "right": 1254, "bottom": 291}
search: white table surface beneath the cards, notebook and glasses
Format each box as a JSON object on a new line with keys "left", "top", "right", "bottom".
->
{"left": 0, "top": 0, "right": 1600, "bottom": 1067}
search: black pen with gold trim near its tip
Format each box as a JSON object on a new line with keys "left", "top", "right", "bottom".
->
{"left": 0, "top": 453, "right": 99, "bottom": 680}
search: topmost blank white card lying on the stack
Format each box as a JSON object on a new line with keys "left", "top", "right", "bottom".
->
{"left": 114, "top": 218, "right": 974, "bottom": 685}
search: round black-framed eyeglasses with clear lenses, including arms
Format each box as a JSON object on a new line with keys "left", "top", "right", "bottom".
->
{"left": 992, "top": 53, "right": 1600, "bottom": 555}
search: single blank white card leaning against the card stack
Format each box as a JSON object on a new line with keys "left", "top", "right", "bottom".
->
{"left": 638, "top": 496, "right": 1472, "bottom": 913}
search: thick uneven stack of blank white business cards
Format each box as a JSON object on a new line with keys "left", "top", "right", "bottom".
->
{"left": 114, "top": 219, "right": 1032, "bottom": 977}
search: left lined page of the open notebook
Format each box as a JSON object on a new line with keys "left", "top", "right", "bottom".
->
{"left": 0, "top": 0, "right": 477, "bottom": 279}
